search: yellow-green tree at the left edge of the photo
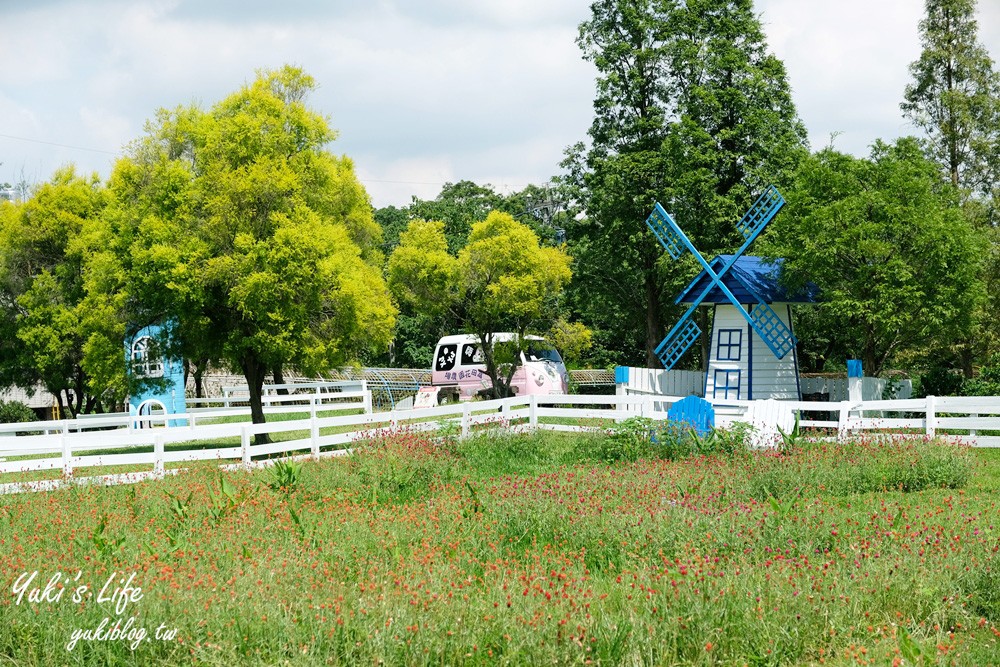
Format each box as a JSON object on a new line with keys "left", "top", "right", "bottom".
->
{"left": 0, "top": 166, "right": 110, "bottom": 416}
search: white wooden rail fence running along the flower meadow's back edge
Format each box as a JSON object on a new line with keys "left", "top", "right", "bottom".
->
{"left": 0, "top": 392, "right": 1000, "bottom": 493}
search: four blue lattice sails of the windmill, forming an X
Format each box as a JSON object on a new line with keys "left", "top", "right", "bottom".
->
{"left": 646, "top": 185, "right": 796, "bottom": 370}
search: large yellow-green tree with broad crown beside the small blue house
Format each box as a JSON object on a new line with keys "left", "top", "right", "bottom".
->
{"left": 89, "top": 66, "right": 396, "bottom": 436}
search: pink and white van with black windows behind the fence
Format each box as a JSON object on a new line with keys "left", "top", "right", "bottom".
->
{"left": 417, "top": 333, "right": 569, "bottom": 405}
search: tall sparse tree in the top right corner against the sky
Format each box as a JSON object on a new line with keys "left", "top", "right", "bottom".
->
{"left": 900, "top": 0, "right": 1000, "bottom": 195}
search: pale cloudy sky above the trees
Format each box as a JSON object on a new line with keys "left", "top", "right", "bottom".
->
{"left": 0, "top": 0, "right": 1000, "bottom": 206}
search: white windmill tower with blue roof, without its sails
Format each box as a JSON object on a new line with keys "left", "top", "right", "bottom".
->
{"left": 676, "top": 255, "right": 817, "bottom": 400}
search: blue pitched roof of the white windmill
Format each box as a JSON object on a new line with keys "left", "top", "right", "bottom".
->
{"left": 675, "top": 255, "right": 819, "bottom": 303}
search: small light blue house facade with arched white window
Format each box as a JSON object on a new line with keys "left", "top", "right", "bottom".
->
{"left": 125, "top": 324, "right": 187, "bottom": 426}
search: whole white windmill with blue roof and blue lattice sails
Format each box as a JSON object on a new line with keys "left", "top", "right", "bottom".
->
{"left": 646, "top": 186, "right": 814, "bottom": 399}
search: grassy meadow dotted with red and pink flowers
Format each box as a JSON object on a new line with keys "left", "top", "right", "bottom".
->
{"left": 0, "top": 430, "right": 1000, "bottom": 665}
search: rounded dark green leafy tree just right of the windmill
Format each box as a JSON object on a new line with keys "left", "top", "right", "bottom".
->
{"left": 768, "top": 138, "right": 983, "bottom": 375}
